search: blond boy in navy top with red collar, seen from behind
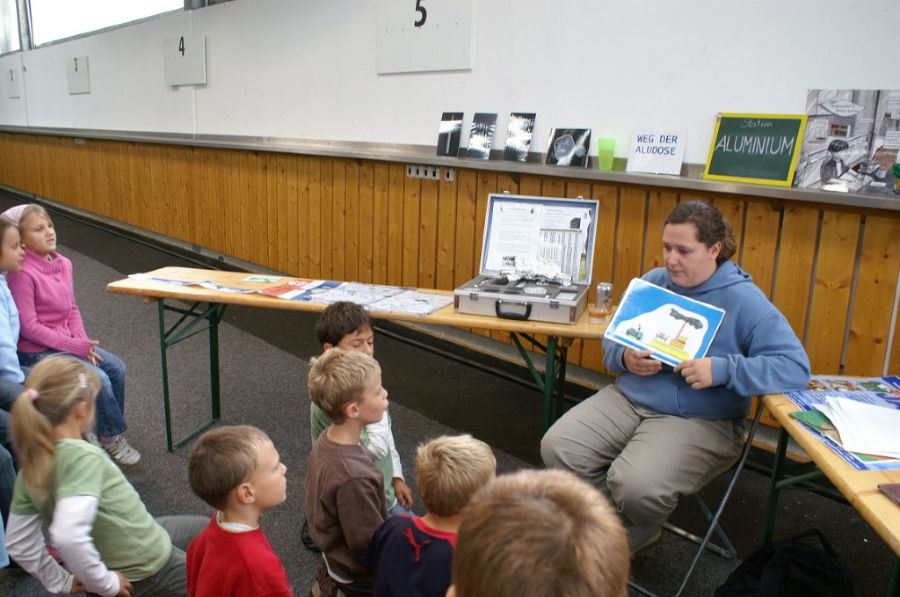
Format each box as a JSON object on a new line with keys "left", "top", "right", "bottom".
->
{"left": 363, "top": 435, "right": 497, "bottom": 597}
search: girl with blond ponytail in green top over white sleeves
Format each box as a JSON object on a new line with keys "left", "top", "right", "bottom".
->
{"left": 7, "top": 357, "right": 206, "bottom": 596}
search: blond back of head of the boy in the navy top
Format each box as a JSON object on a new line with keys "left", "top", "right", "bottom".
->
{"left": 416, "top": 435, "right": 497, "bottom": 517}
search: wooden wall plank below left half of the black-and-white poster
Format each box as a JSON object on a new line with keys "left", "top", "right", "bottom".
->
{"left": 806, "top": 211, "right": 860, "bottom": 374}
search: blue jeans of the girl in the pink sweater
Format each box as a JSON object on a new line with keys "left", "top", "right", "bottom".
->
{"left": 19, "top": 347, "right": 128, "bottom": 437}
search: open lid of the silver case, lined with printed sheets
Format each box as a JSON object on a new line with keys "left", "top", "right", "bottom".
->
{"left": 481, "top": 193, "right": 599, "bottom": 284}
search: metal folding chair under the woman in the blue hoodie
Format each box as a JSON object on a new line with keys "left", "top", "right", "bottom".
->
{"left": 628, "top": 403, "right": 763, "bottom": 597}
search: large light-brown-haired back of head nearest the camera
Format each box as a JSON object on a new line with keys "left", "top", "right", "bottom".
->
{"left": 448, "top": 470, "right": 630, "bottom": 597}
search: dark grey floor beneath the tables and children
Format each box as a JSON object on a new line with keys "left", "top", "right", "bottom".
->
{"left": 0, "top": 195, "right": 892, "bottom": 596}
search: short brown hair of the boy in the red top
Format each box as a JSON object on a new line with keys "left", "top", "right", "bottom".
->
{"left": 188, "top": 425, "right": 284, "bottom": 510}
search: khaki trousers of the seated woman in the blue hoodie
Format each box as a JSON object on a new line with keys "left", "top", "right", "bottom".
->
{"left": 541, "top": 384, "right": 744, "bottom": 553}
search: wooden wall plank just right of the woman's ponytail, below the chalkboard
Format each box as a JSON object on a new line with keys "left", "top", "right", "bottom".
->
{"left": 735, "top": 201, "right": 782, "bottom": 297}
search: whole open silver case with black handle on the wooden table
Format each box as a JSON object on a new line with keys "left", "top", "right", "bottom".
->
{"left": 455, "top": 194, "right": 598, "bottom": 323}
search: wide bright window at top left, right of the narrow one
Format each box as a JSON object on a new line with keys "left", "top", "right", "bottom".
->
{"left": 29, "top": 0, "right": 184, "bottom": 46}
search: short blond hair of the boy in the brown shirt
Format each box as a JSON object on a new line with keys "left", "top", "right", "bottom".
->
{"left": 307, "top": 348, "right": 381, "bottom": 425}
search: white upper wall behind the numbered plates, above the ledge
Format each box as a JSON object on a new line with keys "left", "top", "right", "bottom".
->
{"left": 0, "top": 0, "right": 900, "bottom": 163}
